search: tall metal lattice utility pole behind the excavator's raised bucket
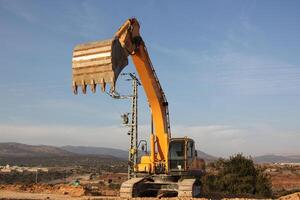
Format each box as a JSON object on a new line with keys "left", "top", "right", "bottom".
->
{"left": 109, "top": 73, "right": 141, "bottom": 179}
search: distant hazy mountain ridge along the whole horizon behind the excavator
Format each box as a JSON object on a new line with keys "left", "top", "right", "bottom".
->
{"left": 0, "top": 142, "right": 300, "bottom": 163}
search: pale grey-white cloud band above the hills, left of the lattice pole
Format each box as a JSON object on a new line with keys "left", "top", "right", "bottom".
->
{"left": 0, "top": 124, "right": 128, "bottom": 149}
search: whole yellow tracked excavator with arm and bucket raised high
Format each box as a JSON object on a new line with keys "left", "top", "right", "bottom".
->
{"left": 72, "top": 18, "right": 205, "bottom": 198}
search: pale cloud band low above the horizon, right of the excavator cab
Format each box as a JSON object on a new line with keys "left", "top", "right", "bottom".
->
{"left": 173, "top": 125, "right": 300, "bottom": 157}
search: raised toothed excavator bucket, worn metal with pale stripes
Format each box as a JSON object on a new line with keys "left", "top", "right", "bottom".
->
{"left": 72, "top": 38, "right": 128, "bottom": 94}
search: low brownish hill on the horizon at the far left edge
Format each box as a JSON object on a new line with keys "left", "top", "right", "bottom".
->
{"left": 0, "top": 142, "right": 74, "bottom": 157}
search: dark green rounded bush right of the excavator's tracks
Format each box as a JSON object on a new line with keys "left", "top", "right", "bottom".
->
{"left": 202, "top": 154, "right": 272, "bottom": 197}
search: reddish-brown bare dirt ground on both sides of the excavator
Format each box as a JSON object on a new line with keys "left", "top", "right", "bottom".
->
{"left": 0, "top": 165, "right": 300, "bottom": 200}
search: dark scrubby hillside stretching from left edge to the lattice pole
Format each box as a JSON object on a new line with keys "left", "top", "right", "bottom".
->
{"left": 0, "top": 143, "right": 127, "bottom": 172}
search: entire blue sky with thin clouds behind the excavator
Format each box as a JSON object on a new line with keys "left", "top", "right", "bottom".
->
{"left": 0, "top": 0, "right": 300, "bottom": 156}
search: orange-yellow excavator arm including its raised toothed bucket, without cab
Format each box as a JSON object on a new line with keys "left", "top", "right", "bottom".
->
{"left": 72, "top": 18, "right": 171, "bottom": 173}
